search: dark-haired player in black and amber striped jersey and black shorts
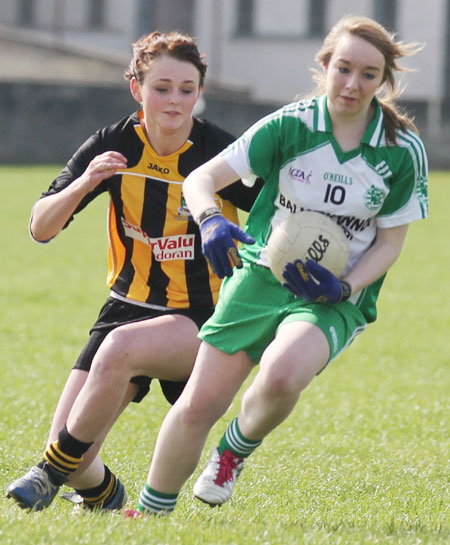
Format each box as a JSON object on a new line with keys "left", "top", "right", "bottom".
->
{"left": 8, "top": 32, "right": 259, "bottom": 510}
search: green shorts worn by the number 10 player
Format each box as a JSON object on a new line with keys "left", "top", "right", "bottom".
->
{"left": 199, "top": 262, "right": 367, "bottom": 363}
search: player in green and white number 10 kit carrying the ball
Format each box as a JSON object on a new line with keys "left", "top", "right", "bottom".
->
{"left": 129, "top": 13, "right": 427, "bottom": 516}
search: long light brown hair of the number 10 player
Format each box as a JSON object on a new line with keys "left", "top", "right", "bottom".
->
{"left": 313, "top": 15, "right": 423, "bottom": 144}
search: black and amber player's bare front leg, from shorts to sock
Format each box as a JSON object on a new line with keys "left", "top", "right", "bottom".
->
{"left": 67, "top": 314, "right": 199, "bottom": 443}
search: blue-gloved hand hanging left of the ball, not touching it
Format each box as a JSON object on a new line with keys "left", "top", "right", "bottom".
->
{"left": 200, "top": 214, "right": 255, "bottom": 278}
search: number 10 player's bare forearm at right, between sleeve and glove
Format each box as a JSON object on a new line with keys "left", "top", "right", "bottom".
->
{"left": 344, "top": 224, "right": 409, "bottom": 293}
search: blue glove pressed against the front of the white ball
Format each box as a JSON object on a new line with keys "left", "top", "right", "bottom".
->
{"left": 282, "top": 259, "right": 351, "bottom": 303}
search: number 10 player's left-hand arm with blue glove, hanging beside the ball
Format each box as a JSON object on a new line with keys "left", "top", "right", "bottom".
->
{"left": 183, "top": 156, "right": 254, "bottom": 278}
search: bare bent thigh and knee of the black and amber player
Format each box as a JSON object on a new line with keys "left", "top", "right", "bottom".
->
{"left": 93, "top": 314, "right": 200, "bottom": 380}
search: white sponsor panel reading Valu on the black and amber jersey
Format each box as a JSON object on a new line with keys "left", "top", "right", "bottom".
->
{"left": 122, "top": 218, "right": 195, "bottom": 261}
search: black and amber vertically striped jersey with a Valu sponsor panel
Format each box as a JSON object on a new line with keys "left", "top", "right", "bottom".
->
{"left": 42, "top": 112, "right": 262, "bottom": 308}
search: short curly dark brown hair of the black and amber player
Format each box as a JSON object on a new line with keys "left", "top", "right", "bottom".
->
{"left": 124, "top": 31, "right": 208, "bottom": 87}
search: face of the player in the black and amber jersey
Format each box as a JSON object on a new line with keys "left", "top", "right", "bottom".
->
{"left": 135, "top": 55, "right": 200, "bottom": 132}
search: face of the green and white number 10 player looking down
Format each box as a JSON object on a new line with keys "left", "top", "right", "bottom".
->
{"left": 325, "top": 34, "right": 385, "bottom": 118}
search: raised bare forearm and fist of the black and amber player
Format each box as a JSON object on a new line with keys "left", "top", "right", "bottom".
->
{"left": 30, "top": 151, "right": 127, "bottom": 242}
